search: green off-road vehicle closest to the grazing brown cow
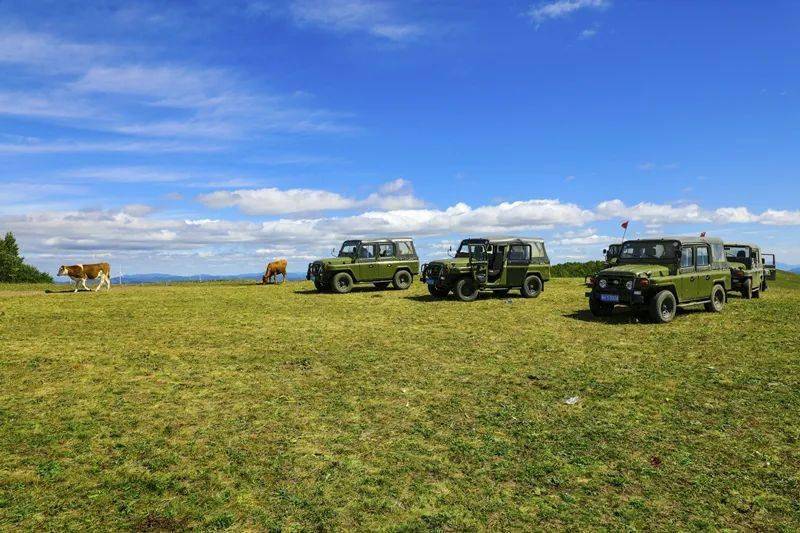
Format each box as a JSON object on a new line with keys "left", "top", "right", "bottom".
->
{"left": 306, "top": 238, "right": 419, "bottom": 294}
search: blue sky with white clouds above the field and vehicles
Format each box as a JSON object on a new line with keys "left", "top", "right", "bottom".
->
{"left": 0, "top": 0, "right": 800, "bottom": 274}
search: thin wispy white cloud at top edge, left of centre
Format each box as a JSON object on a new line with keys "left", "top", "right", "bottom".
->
{"left": 289, "top": 0, "right": 423, "bottom": 42}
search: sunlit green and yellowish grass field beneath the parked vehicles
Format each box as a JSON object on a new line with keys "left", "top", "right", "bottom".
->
{"left": 0, "top": 274, "right": 800, "bottom": 531}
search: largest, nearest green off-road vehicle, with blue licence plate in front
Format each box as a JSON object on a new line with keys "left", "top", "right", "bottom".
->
{"left": 586, "top": 237, "right": 731, "bottom": 323}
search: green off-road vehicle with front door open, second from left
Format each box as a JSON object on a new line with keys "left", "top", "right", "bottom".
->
{"left": 420, "top": 238, "right": 550, "bottom": 302}
